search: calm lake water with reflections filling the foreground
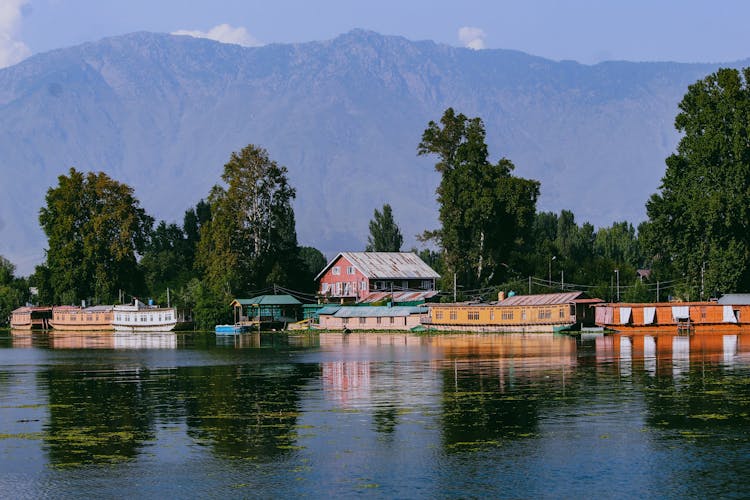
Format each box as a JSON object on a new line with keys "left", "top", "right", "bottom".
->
{"left": 0, "top": 332, "right": 750, "bottom": 498}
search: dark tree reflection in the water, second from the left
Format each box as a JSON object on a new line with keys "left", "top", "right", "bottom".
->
{"left": 178, "top": 364, "right": 320, "bottom": 459}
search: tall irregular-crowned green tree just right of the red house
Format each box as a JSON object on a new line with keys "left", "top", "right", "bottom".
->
{"left": 424, "top": 108, "right": 539, "bottom": 288}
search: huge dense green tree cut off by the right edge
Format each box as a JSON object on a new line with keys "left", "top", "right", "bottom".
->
{"left": 644, "top": 68, "right": 750, "bottom": 298}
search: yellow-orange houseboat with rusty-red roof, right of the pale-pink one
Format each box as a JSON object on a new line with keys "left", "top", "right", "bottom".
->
{"left": 423, "top": 292, "right": 602, "bottom": 333}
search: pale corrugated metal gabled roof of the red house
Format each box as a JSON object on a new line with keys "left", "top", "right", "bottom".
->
{"left": 315, "top": 252, "right": 440, "bottom": 280}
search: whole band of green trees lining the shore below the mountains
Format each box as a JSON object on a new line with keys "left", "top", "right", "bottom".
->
{"left": 0, "top": 68, "right": 750, "bottom": 331}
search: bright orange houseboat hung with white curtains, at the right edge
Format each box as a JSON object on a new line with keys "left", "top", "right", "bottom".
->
{"left": 596, "top": 294, "right": 750, "bottom": 335}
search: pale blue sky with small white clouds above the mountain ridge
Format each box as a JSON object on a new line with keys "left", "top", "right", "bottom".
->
{"left": 0, "top": 0, "right": 750, "bottom": 67}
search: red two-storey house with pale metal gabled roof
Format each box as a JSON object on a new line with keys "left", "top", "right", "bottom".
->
{"left": 315, "top": 252, "right": 440, "bottom": 302}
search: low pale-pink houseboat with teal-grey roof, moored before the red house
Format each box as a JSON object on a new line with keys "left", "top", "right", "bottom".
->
{"left": 319, "top": 306, "right": 427, "bottom": 330}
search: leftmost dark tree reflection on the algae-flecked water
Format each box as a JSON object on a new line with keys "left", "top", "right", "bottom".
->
{"left": 39, "top": 368, "right": 155, "bottom": 465}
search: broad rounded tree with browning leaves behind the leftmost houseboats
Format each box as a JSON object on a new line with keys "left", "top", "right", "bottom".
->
{"left": 39, "top": 168, "right": 153, "bottom": 303}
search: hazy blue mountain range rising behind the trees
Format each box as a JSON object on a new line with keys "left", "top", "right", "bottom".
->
{"left": 0, "top": 30, "right": 748, "bottom": 274}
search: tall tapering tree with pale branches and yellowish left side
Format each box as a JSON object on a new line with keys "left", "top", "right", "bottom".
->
{"left": 196, "top": 145, "right": 303, "bottom": 294}
